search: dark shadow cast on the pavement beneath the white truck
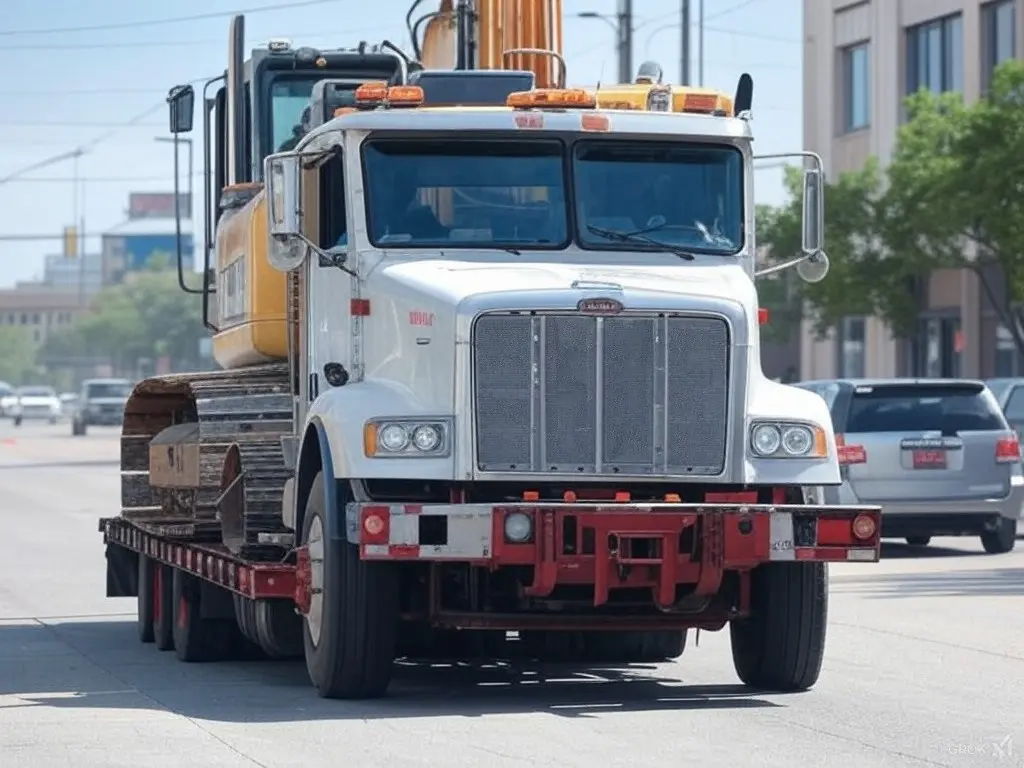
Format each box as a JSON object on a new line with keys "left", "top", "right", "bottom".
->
{"left": 0, "top": 621, "right": 780, "bottom": 723}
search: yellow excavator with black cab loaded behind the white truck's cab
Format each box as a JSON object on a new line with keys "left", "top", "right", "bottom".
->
{"left": 122, "top": 0, "right": 565, "bottom": 536}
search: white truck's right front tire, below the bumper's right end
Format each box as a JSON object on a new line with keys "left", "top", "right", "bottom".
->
{"left": 729, "top": 562, "right": 828, "bottom": 692}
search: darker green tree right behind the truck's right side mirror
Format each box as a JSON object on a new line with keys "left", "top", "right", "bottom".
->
{"left": 758, "top": 160, "right": 906, "bottom": 334}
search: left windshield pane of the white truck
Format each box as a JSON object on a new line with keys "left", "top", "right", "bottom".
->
{"left": 362, "top": 138, "right": 569, "bottom": 249}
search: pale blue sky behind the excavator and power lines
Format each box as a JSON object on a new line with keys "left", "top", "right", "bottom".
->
{"left": 0, "top": 0, "right": 803, "bottom": 287}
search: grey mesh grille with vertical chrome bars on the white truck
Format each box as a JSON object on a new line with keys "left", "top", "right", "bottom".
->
{"left": 473, "top": 313, "right": 729, "bottom": 476}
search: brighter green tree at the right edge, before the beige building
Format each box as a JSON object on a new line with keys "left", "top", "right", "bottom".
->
{"left": 883, "top": 60, "right": 1024, "bottom": 352}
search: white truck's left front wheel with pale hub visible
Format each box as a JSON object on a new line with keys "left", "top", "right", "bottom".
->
{"left": 302, "top": 472, "right": 399, "bottom": 698}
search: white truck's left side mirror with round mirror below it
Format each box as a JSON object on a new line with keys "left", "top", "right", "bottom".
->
{"left": 263, "top": 152, "right": 308, "bottom": 272}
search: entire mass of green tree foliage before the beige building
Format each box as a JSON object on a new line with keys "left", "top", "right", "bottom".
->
{"left": 760, "top": 60, "right": 1024, "bottom": 351}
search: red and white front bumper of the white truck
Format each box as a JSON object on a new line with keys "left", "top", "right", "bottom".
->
{"left": 348, "top": 502, "right": 881, "bottom": 607}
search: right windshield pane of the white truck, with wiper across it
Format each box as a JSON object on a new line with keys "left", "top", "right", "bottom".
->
{"left": 572, "top": 140, "right": 743, "bottom": 255}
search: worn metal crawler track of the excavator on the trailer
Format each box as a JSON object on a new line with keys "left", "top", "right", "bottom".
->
{"left": 121, "top": 362, "right": 293, "bottom": 559}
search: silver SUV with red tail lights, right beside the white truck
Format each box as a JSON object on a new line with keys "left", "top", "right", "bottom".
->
{"left": 798, "top": 379, "right": 1024, "bottom": 554}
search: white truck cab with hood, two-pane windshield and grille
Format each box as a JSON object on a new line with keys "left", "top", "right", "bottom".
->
{"left": 267, "top": 82, "right": 839, "bottom": 486}
